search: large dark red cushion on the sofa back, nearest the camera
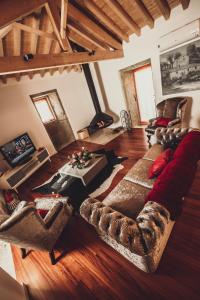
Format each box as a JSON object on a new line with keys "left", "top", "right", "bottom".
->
{"left": 145, "top": 159, "right": 197, "bottom": 219}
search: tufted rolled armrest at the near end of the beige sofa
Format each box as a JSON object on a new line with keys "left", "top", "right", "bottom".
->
{"left": 80, "top": 198, "right": 145, "bottom": 255}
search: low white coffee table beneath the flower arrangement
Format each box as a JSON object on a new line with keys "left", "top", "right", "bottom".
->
{"left": 58, "top": 155, "right": 108, "bottom": 186}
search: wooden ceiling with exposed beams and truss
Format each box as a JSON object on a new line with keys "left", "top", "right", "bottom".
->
{"left": 0, "top": 0, "right": 190, "bottom": 83}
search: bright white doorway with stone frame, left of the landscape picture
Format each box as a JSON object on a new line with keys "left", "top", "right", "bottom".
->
{"left": 121, "top": 60, "right": 156, "bottom": 127}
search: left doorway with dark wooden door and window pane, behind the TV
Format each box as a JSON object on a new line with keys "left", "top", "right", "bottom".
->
{"left": 30, "top": 90, "right": 75, "bottom": 151}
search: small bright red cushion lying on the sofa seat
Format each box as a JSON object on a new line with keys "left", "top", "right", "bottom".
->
{"left": 149, "top": 149, "right": 173, "bottom": 179}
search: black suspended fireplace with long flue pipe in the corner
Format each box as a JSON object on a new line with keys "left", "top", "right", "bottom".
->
{"left": 82, "top": 64, "right": 113, "bottom": 134}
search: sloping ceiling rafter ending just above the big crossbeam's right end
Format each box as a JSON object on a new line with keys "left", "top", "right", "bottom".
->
{"left": 84, "top": 0, "right": 129, "bottom": 42}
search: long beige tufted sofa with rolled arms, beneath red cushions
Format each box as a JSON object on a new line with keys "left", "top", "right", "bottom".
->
{"left": 80, "top": 128, "right": 189, "bottom": 272}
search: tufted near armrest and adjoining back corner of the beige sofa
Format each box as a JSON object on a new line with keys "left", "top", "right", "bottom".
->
{"left": 80, "top": 199, "right": 174, "bottom": 272}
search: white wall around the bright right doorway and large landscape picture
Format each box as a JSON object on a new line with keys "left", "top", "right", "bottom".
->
{"left": 99, "top": 0, "right": 200, "bottom": 127}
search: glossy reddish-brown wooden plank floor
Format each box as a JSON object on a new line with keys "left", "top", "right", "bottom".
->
{"left": 13, "top": 129, "right": 200, "bottom": 300}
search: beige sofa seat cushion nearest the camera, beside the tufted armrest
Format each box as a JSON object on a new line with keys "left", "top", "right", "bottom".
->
{"left": 103, "top": 179, "right": 150, "bottom": 219}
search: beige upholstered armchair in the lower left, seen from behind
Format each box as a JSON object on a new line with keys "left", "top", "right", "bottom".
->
{"left": 0, "top": 193, "right": 73, "bottom": 264}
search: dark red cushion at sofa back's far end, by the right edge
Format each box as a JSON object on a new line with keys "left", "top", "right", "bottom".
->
{"left": 174, "top": 131, "right": 200, "bottom": 163}
